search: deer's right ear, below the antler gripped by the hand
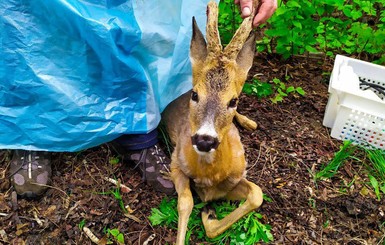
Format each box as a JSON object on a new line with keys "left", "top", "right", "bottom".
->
{"left": 236, "top": 31, "right": 256, "bottom": 74}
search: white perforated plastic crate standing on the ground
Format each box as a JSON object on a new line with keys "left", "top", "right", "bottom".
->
{"left": 323, "top": 55, "right": 385, "bottom": 150}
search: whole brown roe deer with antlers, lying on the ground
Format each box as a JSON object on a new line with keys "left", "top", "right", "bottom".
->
{"left": 162, "top": 1, "right": 262, "bottom": 245}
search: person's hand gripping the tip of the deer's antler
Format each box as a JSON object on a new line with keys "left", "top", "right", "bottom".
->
{"left": 234, "top": 0, "right": 278, "bottom": 27}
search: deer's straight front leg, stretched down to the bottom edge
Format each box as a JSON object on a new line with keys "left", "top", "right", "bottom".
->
{"left": 171, "top": 168, "right": 194, "bottom": 245}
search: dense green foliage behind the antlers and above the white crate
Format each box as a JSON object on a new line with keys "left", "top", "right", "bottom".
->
{"left": 219, "top": 0, "right": 385, "bottom": 64}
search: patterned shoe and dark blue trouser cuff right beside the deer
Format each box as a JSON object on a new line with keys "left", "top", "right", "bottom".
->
{"left": 116, "top": 129, "right": 175, "bottom": 194}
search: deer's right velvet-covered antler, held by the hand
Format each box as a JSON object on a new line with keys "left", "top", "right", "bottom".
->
{"left": 224, "top": 0, "right": 259, "bottom": 60}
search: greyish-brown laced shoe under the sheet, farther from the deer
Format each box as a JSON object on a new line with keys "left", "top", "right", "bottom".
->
{"left": 9, "top": 150, "right": 52, "bottom": 197}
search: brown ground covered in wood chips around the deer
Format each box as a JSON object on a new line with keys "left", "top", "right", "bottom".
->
{"left": 0, "top": 54, "right": 385, "bottom": 244}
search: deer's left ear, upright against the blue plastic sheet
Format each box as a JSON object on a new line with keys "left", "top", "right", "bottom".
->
{"left": 190, "top": 17, "right": 207, "bottom": 64}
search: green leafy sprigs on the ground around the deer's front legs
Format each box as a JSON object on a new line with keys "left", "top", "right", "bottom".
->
{"left": 149, "top": 199, "right": 273, "bottom": 245}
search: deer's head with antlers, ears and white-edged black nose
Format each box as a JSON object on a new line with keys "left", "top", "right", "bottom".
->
{"left": 189, "top": 1, "right": 258, "bottom": 154}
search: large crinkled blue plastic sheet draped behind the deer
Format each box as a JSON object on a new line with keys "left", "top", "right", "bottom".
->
{"left": 0, "top": 0, "right": 216, "bottom": 151}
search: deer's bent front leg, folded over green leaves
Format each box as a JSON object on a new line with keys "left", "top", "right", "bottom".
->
{"left": 202, "top": 179, "right": 263, "bottom": 238}
